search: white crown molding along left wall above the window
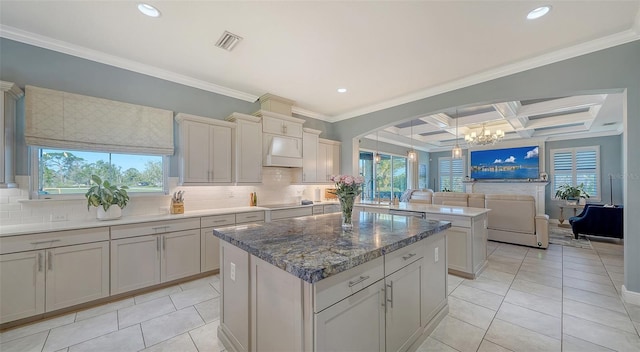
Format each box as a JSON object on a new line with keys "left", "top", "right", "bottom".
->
{"left": 0, "top": 24, "right": 258, "bottom": 103}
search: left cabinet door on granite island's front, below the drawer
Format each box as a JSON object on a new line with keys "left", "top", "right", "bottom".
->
{"left": 315, "top": 280, "right": 384, "bottom": 352}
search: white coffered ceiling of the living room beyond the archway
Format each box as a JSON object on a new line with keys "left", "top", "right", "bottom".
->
{"left": 365, "top": 93, "right": 623, "bottom": 151}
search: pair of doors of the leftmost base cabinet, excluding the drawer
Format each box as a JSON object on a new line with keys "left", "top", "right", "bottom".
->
{"left": 0, "top": 241, "right": 109, "bottom": 323}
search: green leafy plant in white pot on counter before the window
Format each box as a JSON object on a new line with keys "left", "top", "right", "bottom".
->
{"left": 84, "top": 175, "right": 129, "bottom": 220}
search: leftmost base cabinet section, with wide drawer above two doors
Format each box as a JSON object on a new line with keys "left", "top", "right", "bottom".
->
{"left": 0, "top": 227, "right": 109, "bottom": 323}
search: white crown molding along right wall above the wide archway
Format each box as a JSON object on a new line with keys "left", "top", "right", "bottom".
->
{"left": 328, "top": 27, "right": 640, "bottom": 122}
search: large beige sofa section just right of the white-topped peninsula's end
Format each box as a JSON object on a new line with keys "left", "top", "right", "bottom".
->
{"left": 485, "top": 194, "right": 549, "bottom": 248}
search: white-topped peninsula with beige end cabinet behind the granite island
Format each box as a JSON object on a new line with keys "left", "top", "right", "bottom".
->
{"left": 355, "top": 202, "right": 491, "bottom": 279}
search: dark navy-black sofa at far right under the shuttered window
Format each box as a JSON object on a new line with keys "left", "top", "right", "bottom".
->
{"left": 569, "top": 204, "right": 624, "bottom": 238}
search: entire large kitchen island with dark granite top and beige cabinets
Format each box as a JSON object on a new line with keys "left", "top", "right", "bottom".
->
{"left": 214, "top": 211, "right": 451, "bottom": 351}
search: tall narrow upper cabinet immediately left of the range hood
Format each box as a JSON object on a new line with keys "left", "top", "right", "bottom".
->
{"left": 226, "top": 112, "right": 262, "bottom": 183}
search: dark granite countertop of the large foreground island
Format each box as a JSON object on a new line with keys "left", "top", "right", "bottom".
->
{"left": 213, "top": 211, "right": 451, "bottom": 283}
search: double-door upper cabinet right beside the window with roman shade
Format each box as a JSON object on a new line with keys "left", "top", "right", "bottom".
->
{"left": 176, "top": 114, "right": 236, "bottom": 185}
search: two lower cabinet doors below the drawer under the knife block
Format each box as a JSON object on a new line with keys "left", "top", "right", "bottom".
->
{"left": 111, "top": 229, "right": 200, "bottom": 295}
